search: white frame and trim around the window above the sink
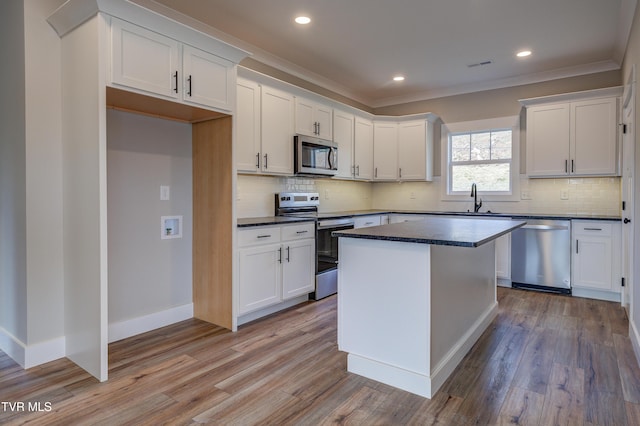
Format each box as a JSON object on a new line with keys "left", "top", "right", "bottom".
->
{"left": 440, "top": 116, "right": 520, "bottom": 202}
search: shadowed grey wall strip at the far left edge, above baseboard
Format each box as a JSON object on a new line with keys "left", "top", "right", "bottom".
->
{"left": 0, "top": 0, "right": 28, "bottom": 346}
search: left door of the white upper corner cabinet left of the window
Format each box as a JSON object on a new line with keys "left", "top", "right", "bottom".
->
{"left": 373, "top": 122, "right": 398, "bottom": 180}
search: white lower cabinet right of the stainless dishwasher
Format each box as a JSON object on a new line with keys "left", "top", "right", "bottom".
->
{"left": 571, "top": 220, "right": 621, "bottom": 300}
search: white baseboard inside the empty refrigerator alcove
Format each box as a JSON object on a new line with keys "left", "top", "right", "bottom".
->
{"left": 109, "top": 303, "right": 193, "bottom": 343}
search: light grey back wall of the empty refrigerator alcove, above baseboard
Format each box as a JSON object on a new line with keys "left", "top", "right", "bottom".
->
{"left": 107, "top": 110, "right": 192, "bottom": 324}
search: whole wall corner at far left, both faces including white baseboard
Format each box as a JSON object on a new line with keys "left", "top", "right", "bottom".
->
{"left": 0, "top": 0, "right": 64, "bottom": 367}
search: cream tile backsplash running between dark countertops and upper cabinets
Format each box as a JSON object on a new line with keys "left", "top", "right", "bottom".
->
{"left": 237, "top": 175, "right": 621, "bottom": 218}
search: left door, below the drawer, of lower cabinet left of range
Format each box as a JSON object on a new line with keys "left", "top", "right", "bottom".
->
{"left": 238, "top": 244, "right": 282, "bottom": 314}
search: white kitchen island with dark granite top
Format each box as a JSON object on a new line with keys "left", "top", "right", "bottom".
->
{"left": 334, "top": 217, "right": 526, "bottom": 398}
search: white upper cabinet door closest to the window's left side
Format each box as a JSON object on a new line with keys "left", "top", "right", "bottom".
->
{"left": 398, "top": 120, "right": 433, "bottom": 180}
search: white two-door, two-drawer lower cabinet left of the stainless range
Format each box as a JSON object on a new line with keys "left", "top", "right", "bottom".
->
{"left": 238, "top": 223, "right": 315, "bottom": 315}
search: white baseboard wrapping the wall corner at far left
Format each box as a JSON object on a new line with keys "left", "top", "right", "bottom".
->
{"left": 0, "top": 327, "right": 66, "bottom": 369}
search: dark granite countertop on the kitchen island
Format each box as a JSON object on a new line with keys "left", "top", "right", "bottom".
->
{"left": 332, "top": 217, "right": 526, "bottom": 247}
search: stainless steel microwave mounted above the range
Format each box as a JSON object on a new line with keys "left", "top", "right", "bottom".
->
{"left": 293, "top": 135, "right": 338, "bottom": 176}
